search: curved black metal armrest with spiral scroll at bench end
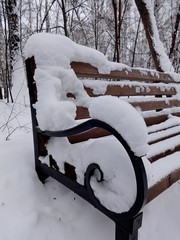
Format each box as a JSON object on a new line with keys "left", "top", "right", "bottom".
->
{"left": 36, "top": 119, "right": 147, "bottom": 222}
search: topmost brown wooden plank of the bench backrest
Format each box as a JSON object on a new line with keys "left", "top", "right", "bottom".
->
{"left": 71, "top": 62, "right": 175, "bottom": 83}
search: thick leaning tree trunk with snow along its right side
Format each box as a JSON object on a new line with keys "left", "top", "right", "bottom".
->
{"left": 135, "top": 0, "right": 174, "bottom": 72}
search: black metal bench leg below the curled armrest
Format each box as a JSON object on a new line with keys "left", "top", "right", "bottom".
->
{"left": 115, "top": 213, "right": 142, "bottom": 240}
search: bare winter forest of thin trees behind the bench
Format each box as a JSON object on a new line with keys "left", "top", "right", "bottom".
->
{"left": 0, "top": 0, "right": 180, "bottom": 102}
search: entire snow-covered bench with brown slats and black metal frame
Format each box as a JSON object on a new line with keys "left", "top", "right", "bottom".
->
{"left": 25, "top": 34, "right": 180, "bottom": 239}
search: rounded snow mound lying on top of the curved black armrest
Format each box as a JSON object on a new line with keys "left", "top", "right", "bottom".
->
{"left": 89, "top": 96, "right": 148, "bottom": 156}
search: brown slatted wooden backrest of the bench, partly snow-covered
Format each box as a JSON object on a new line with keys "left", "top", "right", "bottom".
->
{"left": 71, "top": 62, "right": 180, "bottom": 121}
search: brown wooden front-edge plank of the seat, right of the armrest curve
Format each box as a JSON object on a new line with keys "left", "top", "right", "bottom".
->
{"left": 147, "top": 168, "right": 180, "bottom": 203}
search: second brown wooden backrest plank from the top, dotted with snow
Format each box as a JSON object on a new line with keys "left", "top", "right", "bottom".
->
{"left": 85, "top": 85, "right": 176, "bottom": 97}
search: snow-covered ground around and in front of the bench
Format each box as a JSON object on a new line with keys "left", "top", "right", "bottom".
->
{"left": 0, "top": 35, "right": 180, "bottom": 240}
